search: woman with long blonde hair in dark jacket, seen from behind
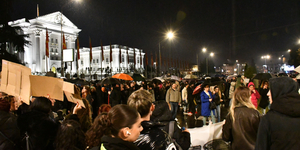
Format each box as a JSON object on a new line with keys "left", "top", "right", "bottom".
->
{"left": 222, "top": 87, "right": 260, "bottom": 150}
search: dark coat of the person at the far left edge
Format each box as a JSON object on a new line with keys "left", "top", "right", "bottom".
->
{"left": 0, "top": 111, "right": 21, "bottom": 150}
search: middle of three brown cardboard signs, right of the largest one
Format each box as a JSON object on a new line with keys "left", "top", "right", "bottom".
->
{"left": 29, "top": 75, "right": 64, "bottom": 101}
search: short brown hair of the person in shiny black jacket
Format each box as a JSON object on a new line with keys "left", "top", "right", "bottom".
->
{"left": 127, "top": 89, "right": 153, "bottom": 117}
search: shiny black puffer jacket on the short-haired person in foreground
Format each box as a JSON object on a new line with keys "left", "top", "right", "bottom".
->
{"left": 134, "top": 121, "right": 176, "bottom": 150}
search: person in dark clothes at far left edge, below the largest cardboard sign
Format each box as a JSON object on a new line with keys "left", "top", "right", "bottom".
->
{"left": 0, "top": 96, "right": 21, "bottom": 150}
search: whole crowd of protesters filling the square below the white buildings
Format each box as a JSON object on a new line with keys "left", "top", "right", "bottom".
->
{"left": 0, "top": 74, "right": 300, "bottom": 150}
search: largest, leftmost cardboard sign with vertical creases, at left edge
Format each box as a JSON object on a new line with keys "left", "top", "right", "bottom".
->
{"left": 1, "top": 60, "right": 31, "bottom": 105}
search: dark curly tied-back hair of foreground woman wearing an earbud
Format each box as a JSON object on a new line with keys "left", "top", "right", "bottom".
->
{"left": 86, "top": 104, "right": 139, "bottom": 147}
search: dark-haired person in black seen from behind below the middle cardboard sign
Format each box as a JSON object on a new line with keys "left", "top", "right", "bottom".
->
{"left": 18, "top": 97, "right": 59, "bottom": 150}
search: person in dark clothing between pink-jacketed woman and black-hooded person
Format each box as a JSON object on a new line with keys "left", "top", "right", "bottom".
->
{"left": 259, "top": 81, "right": 269, "bottom": 115}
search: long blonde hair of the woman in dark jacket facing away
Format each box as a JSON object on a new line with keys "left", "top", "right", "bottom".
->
{"left": 229, "top": 87, "right": 256, "bottom": 122}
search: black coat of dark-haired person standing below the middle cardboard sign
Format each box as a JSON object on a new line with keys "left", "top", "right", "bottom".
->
{"left": 18, "top": 111, "right": 59, "bottom": 150}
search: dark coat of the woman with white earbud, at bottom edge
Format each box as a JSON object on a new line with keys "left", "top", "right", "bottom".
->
{"left": 98, "top": 135, "right": 139, "bottom": 150}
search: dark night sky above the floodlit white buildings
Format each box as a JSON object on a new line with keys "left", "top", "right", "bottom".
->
{"left": 12, "top": 0, "right": 300, "bottom": 65}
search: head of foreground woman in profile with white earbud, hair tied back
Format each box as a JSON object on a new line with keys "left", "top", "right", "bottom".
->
{"left": 87, "top": 104, "right": 143, "bottom": 142}
